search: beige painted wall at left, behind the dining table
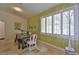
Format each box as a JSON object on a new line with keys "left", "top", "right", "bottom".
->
{"left": 0, "top": 11, "right": 27, "bottom": 42}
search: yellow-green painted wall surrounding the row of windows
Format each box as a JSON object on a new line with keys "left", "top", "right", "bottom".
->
{"left": 27, "top": 3, "right": 78, "bottom": 52}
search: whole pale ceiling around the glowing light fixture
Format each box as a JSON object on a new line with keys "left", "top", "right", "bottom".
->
{"left": 0, "top": 3, "right": 57, "bottom": 18}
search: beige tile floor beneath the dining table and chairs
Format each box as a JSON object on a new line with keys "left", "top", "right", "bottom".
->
{"left": 0, "top": 40, "right": 65, "bottom": 55}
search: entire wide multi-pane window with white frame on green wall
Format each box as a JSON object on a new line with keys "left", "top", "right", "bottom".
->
{"left": 41, "top": 9, "right": 74, "bottom": 36}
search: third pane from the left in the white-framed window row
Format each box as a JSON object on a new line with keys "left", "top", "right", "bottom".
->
{"left": 53, "top": 13, "right": 61, "bottom": 34}
